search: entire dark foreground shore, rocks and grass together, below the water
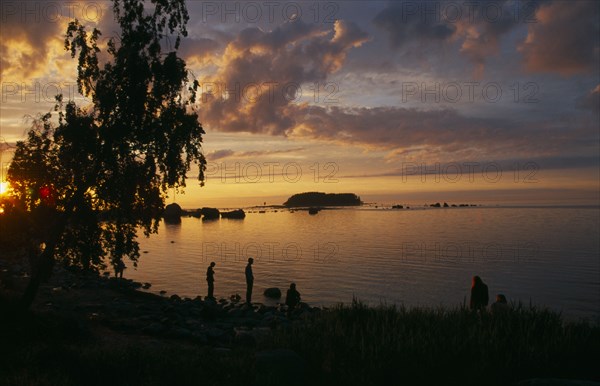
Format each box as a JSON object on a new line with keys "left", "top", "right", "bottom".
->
{"left": 0, "top": 268, "right": 600, "bottom": 386}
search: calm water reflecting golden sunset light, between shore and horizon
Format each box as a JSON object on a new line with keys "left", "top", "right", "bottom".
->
{"left": 126, "top": 208, "right": 600, "bottom": 320}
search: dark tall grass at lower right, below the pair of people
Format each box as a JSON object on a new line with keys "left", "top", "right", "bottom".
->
{"left": 273, "top": 301, "right": 600, "bottom": 385}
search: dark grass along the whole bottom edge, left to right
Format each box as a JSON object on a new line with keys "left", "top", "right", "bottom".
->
{"left": 0, "top": 301, "right": 600, "bottom": 386}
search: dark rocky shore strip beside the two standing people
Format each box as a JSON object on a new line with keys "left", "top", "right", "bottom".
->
{"left": 4, "top": 268, "right": 321, "bottom": 349}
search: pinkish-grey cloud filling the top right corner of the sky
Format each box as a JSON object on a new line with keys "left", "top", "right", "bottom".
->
{"left": 519, "top": 1, "right": 600, "bottom": 76}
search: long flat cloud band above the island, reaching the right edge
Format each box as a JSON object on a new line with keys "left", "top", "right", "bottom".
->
{"left": 290, "top": 102, "right": 597, "bottom": 159}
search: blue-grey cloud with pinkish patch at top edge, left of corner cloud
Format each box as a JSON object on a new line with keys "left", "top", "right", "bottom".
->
{"left": 373, "top": 0, "right": 539, "bottom": 79}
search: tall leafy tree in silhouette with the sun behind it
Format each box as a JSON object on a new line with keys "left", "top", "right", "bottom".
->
{"left": 6, "top": 0, "right": 206, "bottom": 307}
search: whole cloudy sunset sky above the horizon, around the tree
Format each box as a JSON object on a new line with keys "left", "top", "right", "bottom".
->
{"left": 0, "top": 0, "right": 600, "bottom": 208}
